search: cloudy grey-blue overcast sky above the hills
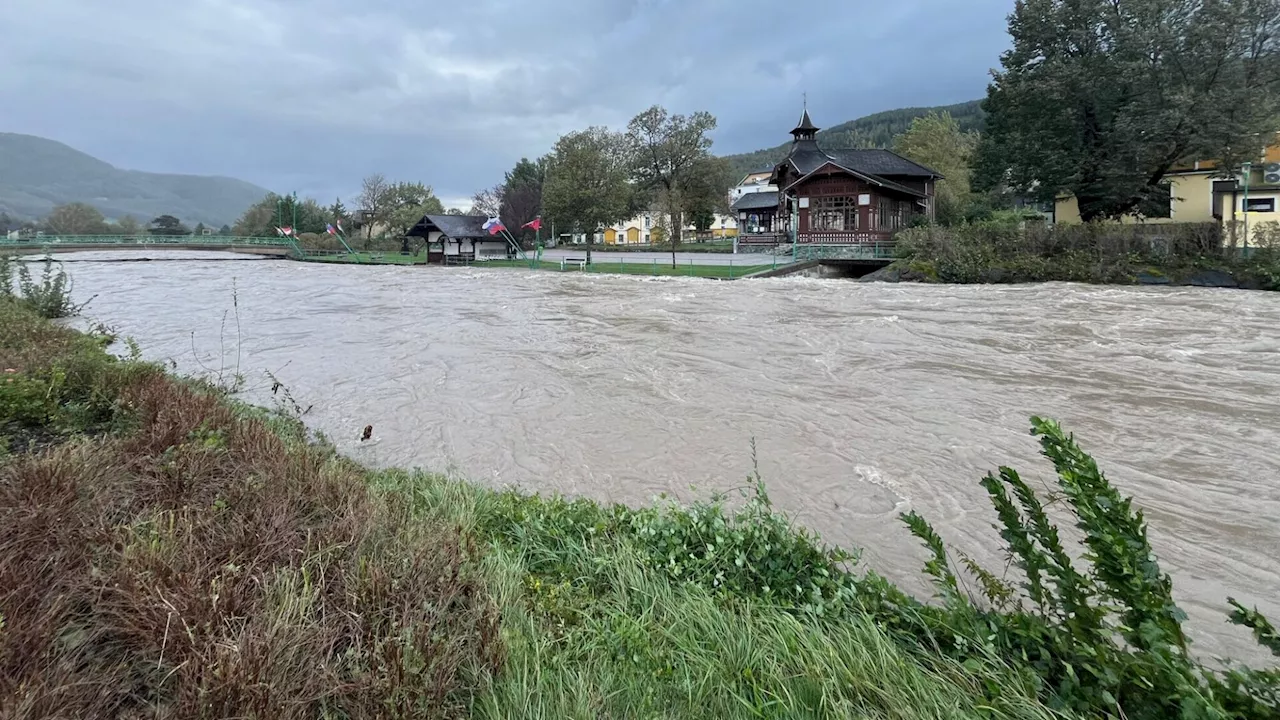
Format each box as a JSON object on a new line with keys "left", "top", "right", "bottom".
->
{"left": 0, "top": 0, "right": 1012, "bottom": 204}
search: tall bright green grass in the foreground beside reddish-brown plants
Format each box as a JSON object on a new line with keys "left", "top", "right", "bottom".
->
{"left": 374, "top": 471, "right": 1064, "bottom": 719}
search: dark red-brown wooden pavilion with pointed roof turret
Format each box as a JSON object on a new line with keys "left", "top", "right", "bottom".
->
{"left": 733, "top": 109, "right": 942, "bottom": 246}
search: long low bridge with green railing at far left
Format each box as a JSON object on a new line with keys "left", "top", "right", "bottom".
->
{"left": 0, "top": 234, "right": 294, "bottom": 258}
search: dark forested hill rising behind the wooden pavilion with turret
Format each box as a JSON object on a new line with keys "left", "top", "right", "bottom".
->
{"left": 728, "top": 100, "right": 986, "bottom": 177}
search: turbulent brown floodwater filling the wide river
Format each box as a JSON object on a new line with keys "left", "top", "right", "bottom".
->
{"left": 57, "top": 255, "right": 1280, "bottom": 660}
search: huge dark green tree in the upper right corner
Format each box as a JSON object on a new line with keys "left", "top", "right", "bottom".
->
{"left": 977, "top": 0, "right": 1280, "bottom": 220}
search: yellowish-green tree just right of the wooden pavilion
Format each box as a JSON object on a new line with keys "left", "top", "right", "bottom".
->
{"left": 893, "top": 111, "right": 979, "bottom": 225}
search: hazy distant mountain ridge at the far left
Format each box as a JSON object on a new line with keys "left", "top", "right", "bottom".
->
{"left": 0, "top": 132, "right": 266, "bottom": 227}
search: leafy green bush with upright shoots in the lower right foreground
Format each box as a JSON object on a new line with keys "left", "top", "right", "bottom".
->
{"left": 896, "top": 418, "right": 1280, "bottom": 720}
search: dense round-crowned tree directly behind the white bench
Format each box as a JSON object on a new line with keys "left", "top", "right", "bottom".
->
{"left": 543, "top": 127, "right": 634, "bottom": 264}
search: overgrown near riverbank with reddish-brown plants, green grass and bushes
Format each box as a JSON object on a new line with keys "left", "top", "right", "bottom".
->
{"left": 0, "top": 286, "right": 1276, "bottom": 717}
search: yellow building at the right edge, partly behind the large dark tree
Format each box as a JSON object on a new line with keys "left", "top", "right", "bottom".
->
{"left": 1053, "top": 133, "right": 1280, "bottom": 245}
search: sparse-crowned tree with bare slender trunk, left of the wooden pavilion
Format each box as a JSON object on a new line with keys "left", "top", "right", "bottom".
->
{"left": 626, "top": 105, "right": 716, "bottom": 268}
